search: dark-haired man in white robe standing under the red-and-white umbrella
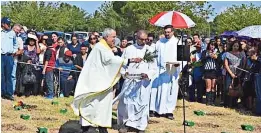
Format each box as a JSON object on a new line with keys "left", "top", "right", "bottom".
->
{"left": 150, "top": 25, "right": 181, "bottom": 120}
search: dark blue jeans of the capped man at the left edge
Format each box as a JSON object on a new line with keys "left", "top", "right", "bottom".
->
{"left": 1, "top": 55, "right": 14, "bottom": 96}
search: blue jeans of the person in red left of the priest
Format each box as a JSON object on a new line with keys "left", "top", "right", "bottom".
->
{"left": 45, "top": 70, "right": 54, "bottom": 97}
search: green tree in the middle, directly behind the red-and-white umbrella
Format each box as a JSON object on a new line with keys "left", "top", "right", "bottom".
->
{"left": 87, "top": 1, "right": 213, "bottom": 36}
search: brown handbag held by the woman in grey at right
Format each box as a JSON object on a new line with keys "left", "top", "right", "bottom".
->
{"left": 228, "top": 78, "right": 243, "bottom": 97}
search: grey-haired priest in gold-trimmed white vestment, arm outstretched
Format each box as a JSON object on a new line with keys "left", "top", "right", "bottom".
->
{"left": 71, "top": 28, "right": 141, "bottom": 133}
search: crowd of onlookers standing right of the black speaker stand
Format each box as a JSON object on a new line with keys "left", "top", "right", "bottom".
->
{"left": 187, "top": 34, "right": 261, "bottom": 111}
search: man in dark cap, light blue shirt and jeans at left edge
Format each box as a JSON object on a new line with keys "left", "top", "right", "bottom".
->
{"left": 1, "top": 17, "right": 18, "bottom": 100}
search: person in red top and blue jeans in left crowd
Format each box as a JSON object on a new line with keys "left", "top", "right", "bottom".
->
{"left": 42, "top": 39, "right": 56, "bottom": 99}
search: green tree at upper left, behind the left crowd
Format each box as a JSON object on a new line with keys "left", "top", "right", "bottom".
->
{"left": 1, "top": 1, "right": 90, "bottom": 31}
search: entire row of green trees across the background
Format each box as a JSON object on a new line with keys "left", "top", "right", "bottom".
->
{"left": 1, "top": 1, "right": 261, "bottom": 36}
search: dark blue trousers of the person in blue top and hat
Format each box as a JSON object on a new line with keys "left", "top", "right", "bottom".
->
{"left": 60, "top": 76, "right": 75, "bottom": 97}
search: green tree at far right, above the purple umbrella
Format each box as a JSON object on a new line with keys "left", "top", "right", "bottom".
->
{"left": 213, "top": 3, "right": 261, "bottom": 33}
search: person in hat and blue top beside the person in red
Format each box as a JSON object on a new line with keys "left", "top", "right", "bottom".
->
{"left": 55, "top": 50, "right": 75, "bottom": 97}
